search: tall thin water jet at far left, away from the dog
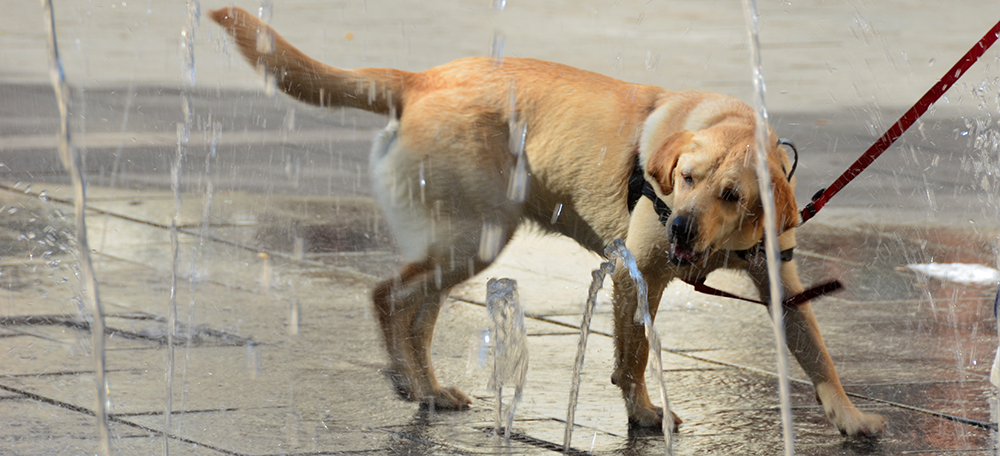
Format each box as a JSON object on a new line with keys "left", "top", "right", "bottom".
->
{"left": 42, "top": 0, "right": 111, "bottom": 455}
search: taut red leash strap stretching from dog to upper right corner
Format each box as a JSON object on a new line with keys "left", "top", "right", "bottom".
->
{"left": 799, "top": 22, "right": 1000, "bottom": 225}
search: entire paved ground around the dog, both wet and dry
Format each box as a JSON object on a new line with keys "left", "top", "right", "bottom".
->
{"left": 0, "top": 1, "right": 1000, "bottom": 455}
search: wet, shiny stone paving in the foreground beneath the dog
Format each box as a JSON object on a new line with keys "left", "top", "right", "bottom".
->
{"left": 0, "top": 177, "right": 996, "bottom": 455}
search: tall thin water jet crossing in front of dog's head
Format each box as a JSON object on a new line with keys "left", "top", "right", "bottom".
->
{"left": 743, "top": 0, "right": 795, "bottom": 456}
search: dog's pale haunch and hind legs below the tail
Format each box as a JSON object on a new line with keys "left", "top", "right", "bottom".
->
{"left": 371, "top": 89, "right": 523, "bottom": 409}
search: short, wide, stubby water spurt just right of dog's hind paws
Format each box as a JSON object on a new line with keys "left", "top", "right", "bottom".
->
{"left": 486, "top": 279, "right": 528, "bottom": 441}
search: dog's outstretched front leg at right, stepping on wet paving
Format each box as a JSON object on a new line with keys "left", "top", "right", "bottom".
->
{"left": 751, "top": 261, "right": 886, "bottom": 437}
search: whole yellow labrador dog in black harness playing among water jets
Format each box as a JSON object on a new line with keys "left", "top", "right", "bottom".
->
{"left": 211, "top": 8, "right": 885, "bottom": 435}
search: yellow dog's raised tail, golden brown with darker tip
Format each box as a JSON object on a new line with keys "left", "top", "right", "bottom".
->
{"left": 210, "top": 7, "right": 414, "bottom": 114}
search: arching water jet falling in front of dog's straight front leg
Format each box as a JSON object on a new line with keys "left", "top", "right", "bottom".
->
{"left": 604, "top": 239, "right": 674, "bottom": 455}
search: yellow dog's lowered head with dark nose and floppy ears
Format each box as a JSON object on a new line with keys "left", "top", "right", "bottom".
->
{"left": 645, "top": 122, "right": 798, "bottom": 265}
